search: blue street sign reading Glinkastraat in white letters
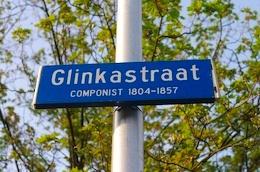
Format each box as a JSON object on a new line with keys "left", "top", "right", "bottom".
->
{"left": 33, "top": 60, "right": 219, "bottom": 109}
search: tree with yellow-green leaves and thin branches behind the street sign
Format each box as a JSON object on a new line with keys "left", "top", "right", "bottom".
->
{"left": 0, "top": 0, "right": 260, "bottom": 171}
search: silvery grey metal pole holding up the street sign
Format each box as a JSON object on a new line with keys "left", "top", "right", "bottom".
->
{"left": 112, "top": 0, "right": 144, "bottom": 172}
